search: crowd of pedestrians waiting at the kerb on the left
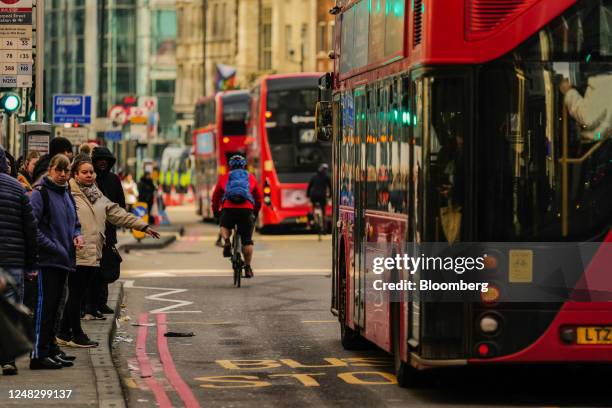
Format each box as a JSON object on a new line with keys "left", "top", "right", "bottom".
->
{"left": 0, "top": 138, "right": 159, "bottom": 375}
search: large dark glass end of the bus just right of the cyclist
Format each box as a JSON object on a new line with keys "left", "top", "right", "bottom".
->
{"left": 266, "top": 77, "right": 330, "bottom": 182}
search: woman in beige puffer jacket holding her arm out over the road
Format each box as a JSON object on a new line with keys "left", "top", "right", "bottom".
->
{"left": 57, "top": 155, "right": 159, "bottom": 347}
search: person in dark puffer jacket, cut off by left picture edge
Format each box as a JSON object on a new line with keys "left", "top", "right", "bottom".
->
{"left": 0, "top": 147, "right": 38, "bottom": 375}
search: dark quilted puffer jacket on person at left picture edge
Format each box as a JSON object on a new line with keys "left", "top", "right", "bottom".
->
{"left": 0, "top": 147, "right": 38, "bottom": 269}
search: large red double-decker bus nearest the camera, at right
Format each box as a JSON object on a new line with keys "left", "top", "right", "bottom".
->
{"left": 317, "top": 0, "right": 612, "bottom": 385}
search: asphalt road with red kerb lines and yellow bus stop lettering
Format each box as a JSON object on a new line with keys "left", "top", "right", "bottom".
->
{"left": 115, "top": 210, "right": 612, "bottom": 407}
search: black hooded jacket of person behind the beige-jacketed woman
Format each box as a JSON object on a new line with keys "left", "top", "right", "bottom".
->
{"left": 91, "top": 146, "right": 125, "bottom": 245}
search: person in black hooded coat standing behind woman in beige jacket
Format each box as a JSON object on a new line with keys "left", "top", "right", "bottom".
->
{"left": 85, "top": 146, "right": 125, "bottom": 319}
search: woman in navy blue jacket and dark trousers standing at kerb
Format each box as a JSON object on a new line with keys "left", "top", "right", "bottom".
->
{"left": 30, "top": 154, "right": 83, "bottom": 370}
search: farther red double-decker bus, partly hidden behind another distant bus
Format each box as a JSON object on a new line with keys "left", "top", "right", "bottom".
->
{"left": 193, "top": 91, "right": 250, "bottom": 219}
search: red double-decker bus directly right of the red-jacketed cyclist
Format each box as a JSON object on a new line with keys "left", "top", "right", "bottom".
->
{"left": 247, "top": 73, "right": 331, "bottom": 231}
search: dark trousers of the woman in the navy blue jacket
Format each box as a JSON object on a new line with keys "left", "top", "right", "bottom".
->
{"left": 32, "top": 268, "right": 68, "bottom": 358}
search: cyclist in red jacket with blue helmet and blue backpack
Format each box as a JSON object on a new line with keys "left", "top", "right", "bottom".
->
{"left": 212, "top": 155, "right": 261, "bottom": 278}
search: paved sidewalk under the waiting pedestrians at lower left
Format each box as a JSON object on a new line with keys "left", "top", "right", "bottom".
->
{"left": 0, "top": 282, "right": 125, "bottom": 408}
